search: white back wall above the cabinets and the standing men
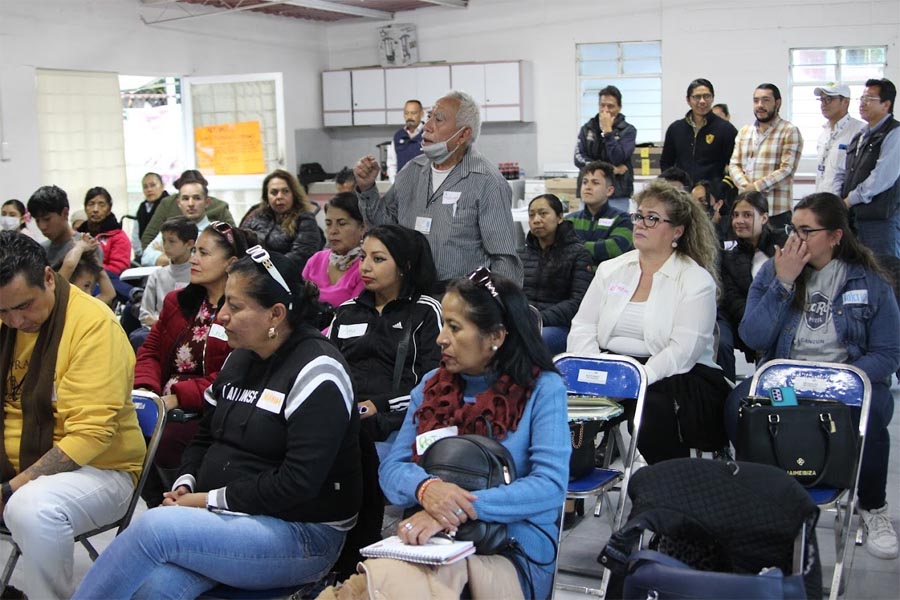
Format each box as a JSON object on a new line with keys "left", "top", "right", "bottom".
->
{"left": 327, "top": 0, "right": 900, "bottom": 173}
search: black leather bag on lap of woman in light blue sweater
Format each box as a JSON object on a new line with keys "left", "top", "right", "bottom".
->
{"left": 419, "top": 435, "right": 516, "bottom": 554}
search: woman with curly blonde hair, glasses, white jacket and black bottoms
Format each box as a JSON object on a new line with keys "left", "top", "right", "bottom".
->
{"left": 567, "top": 181, "right": 730, "bottom": 464}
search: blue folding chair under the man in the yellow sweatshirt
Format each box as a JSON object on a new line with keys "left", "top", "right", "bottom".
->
{"left": 0, "top": 392, "right": 166, "bottom": 596}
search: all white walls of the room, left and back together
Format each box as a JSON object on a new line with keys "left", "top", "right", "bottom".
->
{"left": 0, "top": 0, "right": 900, "bottom": 204}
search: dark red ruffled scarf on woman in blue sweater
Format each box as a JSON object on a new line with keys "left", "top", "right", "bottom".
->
{"left": 413, "top": 366, "right": 540, "bottom": 460}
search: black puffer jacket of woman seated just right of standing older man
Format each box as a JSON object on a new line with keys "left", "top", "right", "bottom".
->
{"left": 519, "top": 221, "right": 594, "bottom": 327}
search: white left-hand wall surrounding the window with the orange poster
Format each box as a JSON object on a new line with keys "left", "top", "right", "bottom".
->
{"left": 0, "top": 0, "right": 328, "bottom": 204}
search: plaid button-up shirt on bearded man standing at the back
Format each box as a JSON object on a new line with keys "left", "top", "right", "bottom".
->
{"left": 728, "top": 117, "right": 803, "bottom": 215}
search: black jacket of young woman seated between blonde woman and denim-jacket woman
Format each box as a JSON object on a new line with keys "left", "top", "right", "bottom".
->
{"left": 719, "top": 225, "right": 787, "bottom": 338}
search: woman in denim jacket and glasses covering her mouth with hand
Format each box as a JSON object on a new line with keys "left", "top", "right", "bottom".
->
{"left": 725, "top": 193, "right": 900, "bottom": 558}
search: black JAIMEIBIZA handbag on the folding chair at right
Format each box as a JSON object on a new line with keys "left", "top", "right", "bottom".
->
{"left": 735, "top": 397, "right": 859, "bottom": 489}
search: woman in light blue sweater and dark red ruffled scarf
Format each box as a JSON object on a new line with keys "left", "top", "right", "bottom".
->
{"left": 379, "top": 267, "right": 571, "bottom": 598}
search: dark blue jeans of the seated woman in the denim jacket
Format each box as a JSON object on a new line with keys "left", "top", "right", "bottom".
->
{"left": 725, "top": 379, "right": 894, "bottom": 510}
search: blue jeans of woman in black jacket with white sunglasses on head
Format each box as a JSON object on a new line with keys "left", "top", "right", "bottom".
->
{"left": 73, "top": 506, "right": 346, "bottom": 599}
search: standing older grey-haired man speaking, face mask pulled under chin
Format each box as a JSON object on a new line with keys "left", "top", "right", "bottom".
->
{"left": 354, "top": 91, "right": 523, "bottom": 285}
